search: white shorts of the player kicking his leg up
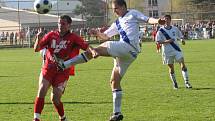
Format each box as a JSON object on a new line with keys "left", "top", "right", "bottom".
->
{"left": 100, "top": 41, "right": 138, "bottom": 77}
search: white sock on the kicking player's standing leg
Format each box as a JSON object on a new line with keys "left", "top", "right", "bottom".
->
{"left": 113, "top": 90, "right": 122, "bottom": 113}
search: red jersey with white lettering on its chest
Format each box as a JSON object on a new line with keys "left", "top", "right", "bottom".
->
{"left": 39, "top": 31, "right": 89, "bottom": 73}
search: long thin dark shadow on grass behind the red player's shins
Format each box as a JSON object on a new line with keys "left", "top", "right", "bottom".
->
{"left": 0, "top": 101, "right": 112, "bottom": 105}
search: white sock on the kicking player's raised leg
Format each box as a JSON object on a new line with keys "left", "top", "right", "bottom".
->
{"left": 64, "top": 53, "right": 89, "bottom": 68}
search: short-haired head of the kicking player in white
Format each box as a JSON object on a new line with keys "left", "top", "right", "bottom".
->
{"left": 112, "top": 0, "right": 127, "bottom": 16}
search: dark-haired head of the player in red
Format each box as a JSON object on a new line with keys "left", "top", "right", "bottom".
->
{"left": 58, "top": 15, "right": 72, "bottom": 33}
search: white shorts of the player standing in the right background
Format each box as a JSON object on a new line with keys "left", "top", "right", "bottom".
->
{"left": 162, "top": 51, "right": 183, "bottom": 64}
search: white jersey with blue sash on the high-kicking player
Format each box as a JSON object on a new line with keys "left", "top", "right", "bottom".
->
{"left": 104, "top": 9, "right": 149, "bottom": 50}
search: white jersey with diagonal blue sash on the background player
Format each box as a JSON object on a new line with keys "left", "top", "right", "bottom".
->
{"left": 156, "top": 26, "right": 183, "bottom": 56}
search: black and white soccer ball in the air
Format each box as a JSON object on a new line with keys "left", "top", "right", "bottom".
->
{"left": 34, "top": 0, "right": 52, "bottom": 14}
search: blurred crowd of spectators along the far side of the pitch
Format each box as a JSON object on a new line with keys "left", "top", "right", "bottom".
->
{"left": 0, "top": 21, "right": 215, "bottom": 46}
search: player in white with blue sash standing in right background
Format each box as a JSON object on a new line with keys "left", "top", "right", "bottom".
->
{"left": 156, "top": 15, "right": 192, "bottom": 89}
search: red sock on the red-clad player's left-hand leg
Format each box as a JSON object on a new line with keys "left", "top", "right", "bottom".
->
{"left": 34, "top": 97, "right": 44, "bottom": 114}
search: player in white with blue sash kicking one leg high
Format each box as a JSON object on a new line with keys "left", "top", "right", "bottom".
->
{"left": 55, "top": 0, "right": 165, "bottom": 121}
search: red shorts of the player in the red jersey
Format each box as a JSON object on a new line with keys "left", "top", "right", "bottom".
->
{"left": 42, "top": 68, "right": 69, "bottom": 87}
